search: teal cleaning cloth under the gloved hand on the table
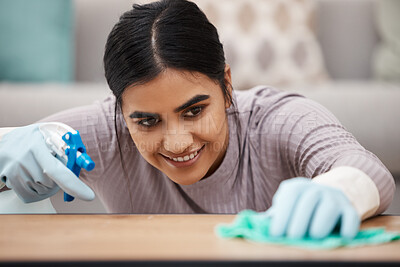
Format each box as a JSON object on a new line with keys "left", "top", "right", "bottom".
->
{"left": 215, "top": 210, "right": 400, "bottom": 249}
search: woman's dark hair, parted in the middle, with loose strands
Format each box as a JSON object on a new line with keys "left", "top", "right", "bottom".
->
{"left": 104, "top": 0, "right": 241, "bottom": 210}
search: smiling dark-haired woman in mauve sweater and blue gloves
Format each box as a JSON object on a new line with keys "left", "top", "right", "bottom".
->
{"left": 0, "top": 0, "right": 394, "bottom": 241}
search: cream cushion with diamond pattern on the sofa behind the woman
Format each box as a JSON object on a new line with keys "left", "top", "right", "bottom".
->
{"left": 194, "top": 0, "right": 327, "bottom": 89}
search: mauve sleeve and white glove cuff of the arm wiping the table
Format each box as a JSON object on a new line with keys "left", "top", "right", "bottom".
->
{"left": 268, "top": 98, "right": 395, "bottom": 219}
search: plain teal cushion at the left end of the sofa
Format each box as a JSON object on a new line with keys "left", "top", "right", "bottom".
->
{"left": 0, "top": 0, "right": 74, "bottom": 82}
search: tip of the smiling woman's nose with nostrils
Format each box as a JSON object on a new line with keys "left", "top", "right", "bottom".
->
{"left": 163, "top": 131, "right": 193, "bottom": 154}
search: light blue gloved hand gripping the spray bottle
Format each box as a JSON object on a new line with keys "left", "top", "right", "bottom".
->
{"left": 0, "top": 124, "right": 95, "bottom": 203}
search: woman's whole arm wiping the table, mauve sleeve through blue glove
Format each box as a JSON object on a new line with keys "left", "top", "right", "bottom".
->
{"left": 258, "top": 93, "right": 395, "bottom": 240}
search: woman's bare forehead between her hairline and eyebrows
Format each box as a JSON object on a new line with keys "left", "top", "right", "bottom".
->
{"left": 122, "top": 69, "right": 223, "bottom": 112}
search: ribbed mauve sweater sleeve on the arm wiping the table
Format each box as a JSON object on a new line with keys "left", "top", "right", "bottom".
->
{"left": 260, "top": 96, "right": 395, "bottom": 215}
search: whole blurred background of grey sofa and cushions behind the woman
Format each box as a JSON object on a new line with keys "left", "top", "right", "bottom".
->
{"left": 0, "top": 0, "right": 400, "bottom": 214}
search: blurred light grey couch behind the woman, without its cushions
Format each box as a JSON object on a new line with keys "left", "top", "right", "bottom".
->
{"left": 0, "top": 0, "right": 400, "bottom": 212}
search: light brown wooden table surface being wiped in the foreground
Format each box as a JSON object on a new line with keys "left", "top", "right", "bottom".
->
{"left": 0, "top": 214, "right": 400, "bottom": 262}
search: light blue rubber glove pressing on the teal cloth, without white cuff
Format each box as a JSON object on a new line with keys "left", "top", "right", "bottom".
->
{"left": 266, "top": 178, "right": 360, "bottom": 239}
